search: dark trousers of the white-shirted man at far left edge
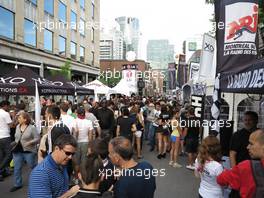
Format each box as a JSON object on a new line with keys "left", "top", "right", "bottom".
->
{"left": 0, "top": 137, "right": 12, "bottom": 175}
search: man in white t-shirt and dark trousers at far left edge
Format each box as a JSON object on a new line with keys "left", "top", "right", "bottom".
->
{"left": 0, "top": 101, "right": 12, "bottom": 181}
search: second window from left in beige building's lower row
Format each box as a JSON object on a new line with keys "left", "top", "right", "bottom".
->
{"left": 24, "top": 19, "right": 37, "bottom": 47}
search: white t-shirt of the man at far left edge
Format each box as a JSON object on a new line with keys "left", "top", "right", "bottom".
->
{"left": 0, "top": 109, "right": 12, "bottom": 139}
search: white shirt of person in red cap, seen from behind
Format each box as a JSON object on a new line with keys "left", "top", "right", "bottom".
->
{"left": 75, "top": 118, "right": 93, "bottom": 142}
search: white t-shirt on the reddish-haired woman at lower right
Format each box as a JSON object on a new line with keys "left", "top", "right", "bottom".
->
{"left": 195, "top": 159, "right": 224, "bottom": 198}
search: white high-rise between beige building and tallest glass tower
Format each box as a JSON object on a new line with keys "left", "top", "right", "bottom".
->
{"left": 100, "top": 23, "right": 124, "bottom": 60}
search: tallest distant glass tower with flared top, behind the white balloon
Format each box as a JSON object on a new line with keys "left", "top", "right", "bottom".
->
{"left": 115, "top": 16, "right": 141, "bottom": 59}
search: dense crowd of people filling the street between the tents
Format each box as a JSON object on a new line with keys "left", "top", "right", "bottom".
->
{"left": 0, "top": 97, "right": 264, "bottom": 198}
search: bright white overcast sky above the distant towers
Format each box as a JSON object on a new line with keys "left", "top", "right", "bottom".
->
{"left": 100, "top": 0, "right": 214, "bottom": 57}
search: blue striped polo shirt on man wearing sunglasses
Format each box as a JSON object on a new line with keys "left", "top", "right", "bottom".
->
{"left": 28, "top": 155, "right": 69, "bottom": 198}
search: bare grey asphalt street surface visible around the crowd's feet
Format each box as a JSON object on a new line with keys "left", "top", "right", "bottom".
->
{"left": 0, "top": 142, "right": 199, "bottom": 198}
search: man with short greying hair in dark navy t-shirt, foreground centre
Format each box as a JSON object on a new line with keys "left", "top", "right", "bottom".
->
{"left": 108, "top": 136, "right": 156, "bottom": 198}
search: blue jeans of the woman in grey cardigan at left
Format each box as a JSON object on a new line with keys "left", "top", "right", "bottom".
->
{"left": 13, "top": 152, "right": 37, "bottom": 187}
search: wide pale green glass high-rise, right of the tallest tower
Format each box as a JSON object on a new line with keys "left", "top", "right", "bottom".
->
{"left": 147, "top": 39, "right": 174, "bottom": 70}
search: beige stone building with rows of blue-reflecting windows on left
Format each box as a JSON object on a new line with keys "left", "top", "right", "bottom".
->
{"left": 0, "top": 0, "right": 100, "bottom": 82}
